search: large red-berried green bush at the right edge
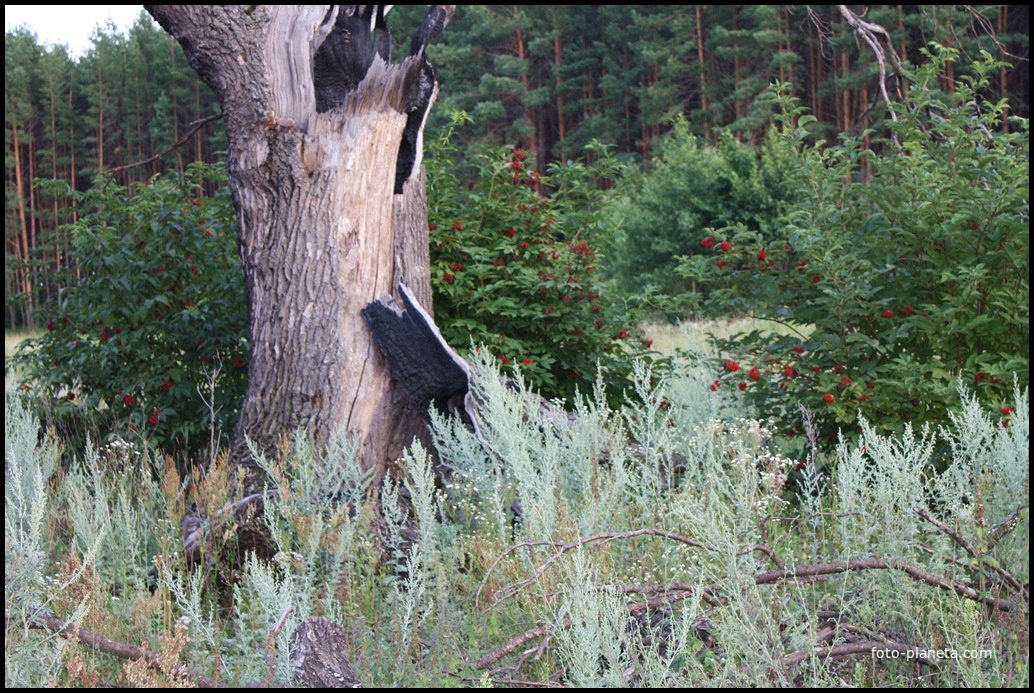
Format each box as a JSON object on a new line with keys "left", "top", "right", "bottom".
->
{"left": 680, "top": 49, "right": 1030, "bottom": 450}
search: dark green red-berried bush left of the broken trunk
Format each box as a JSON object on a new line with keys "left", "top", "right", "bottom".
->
{"left": 16, "top": 164, "right": 248, "bottom": 451}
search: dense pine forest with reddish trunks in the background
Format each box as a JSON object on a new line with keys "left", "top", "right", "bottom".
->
{"left": 4, "top": 5, "right": 1030, "bottom": 329}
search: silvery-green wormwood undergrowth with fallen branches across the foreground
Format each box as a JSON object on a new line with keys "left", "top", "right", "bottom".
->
{"left": 4, "top": 357, "right": 1030, "bottom": 687}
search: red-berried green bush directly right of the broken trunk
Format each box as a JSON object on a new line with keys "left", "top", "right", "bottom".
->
{"left": 427, "top": 114, "right": 649, "bottom": 405}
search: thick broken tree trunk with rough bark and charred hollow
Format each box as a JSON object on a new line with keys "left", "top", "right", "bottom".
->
{"left": 146, "top": 5, "right": 453, "bottom": 492}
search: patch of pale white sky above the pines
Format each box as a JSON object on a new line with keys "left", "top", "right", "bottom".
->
{"left": 3, "top": 5, "right": 144, "bottom": 58}
